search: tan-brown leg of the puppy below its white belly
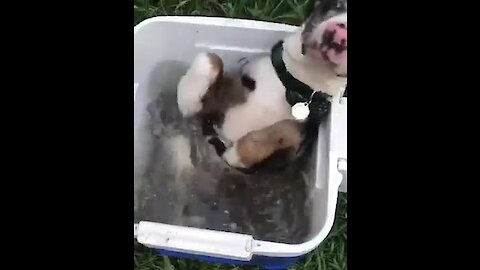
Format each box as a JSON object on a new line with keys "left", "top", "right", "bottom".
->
{"left": 237, "top": 120, "right": 303, "bottom": 167}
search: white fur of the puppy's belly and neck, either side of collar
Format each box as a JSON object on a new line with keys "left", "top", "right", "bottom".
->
{"left": 221, "top": 21, "right": 346, "bottom": 142}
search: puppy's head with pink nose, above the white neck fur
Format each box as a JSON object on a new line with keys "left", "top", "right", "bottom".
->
{"left": 301, "top": 0, "right": 347, "bottom": 76}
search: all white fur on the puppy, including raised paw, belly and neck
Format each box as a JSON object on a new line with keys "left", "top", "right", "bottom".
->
{"left": 177, "top": 14, "right": 346, "bottom": 168}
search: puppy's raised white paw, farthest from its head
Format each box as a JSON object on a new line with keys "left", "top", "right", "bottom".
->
{"left": 177, "top": 53, "right": 218, "bottom": 117}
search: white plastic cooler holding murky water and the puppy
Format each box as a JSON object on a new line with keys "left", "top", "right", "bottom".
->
{"left": 134, "top": 16, "right": 347, "bottom": 269}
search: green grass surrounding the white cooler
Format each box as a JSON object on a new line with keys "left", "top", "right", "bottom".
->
{"left": 133, "top": 0, "right": 347, "bottom": 270}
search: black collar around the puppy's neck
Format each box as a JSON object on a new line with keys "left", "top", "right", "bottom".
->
{"left": 270, "top": 40, "right": 331, "bottom": 106}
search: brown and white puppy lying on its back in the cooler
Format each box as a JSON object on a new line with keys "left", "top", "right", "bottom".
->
{"left": 177, "top": 0, "right": 347, "bottom": 172}
